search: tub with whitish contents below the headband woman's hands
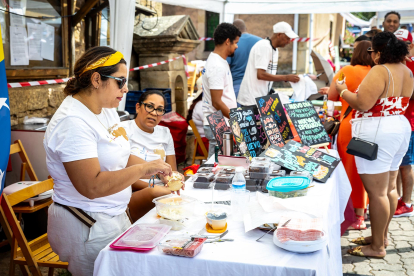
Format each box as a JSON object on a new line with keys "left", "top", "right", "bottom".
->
{"left": 152, "top": 194, "right": 198, "bottom": 220}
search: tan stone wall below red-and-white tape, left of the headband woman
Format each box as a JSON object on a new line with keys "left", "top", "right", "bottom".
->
{"left": 9, "top": 84, "right": 65, "bottom": 126}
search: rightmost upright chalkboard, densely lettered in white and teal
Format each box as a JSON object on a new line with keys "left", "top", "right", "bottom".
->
{"left": 285, "top": 101, "right": 331, "bottom": 146}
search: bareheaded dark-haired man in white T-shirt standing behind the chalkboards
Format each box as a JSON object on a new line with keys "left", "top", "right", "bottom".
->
{"left": 202, "top": 23, "right": 241, "bottom": 157}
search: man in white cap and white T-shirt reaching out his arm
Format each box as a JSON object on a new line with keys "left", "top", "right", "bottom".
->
{"left": 237, "top": 22, "right": 299, "bottom": 106}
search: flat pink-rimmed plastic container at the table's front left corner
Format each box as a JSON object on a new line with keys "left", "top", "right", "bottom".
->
{"left": 109, "top": 224, "right": 171, "bottom": 251}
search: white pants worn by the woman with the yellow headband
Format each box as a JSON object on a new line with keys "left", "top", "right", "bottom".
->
{"left": 47, "top": 204, "right": 131, "bottom": 276}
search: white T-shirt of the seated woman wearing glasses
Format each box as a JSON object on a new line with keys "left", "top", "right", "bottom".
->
{"left": 121, "top": 120, "right": 175, "bottom": 162}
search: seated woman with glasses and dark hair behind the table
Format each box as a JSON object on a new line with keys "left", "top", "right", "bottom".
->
{"left": 121, "top": 90, "right": 184, "bottom": 222}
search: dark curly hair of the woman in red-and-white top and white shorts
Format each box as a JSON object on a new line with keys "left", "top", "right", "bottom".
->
{"left": 372, "top": 32, "right": 408, "bottom": 64}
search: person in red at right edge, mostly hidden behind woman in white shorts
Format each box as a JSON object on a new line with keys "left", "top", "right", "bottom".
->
{"left": 394, "top": 29, "right": 414, "bottom": 217}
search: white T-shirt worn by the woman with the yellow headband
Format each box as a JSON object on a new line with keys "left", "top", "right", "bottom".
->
{"left": 43, "top": 96, "right": 132, "bottom": 216}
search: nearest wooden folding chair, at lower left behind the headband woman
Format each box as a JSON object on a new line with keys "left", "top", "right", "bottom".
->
{"left": 0, "top": 179, "right": 68, "bottom": 276}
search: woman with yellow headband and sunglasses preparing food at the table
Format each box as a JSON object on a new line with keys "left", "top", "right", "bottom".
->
{"left": 43, "top": 47, "right": 171, "bottom": 276}
